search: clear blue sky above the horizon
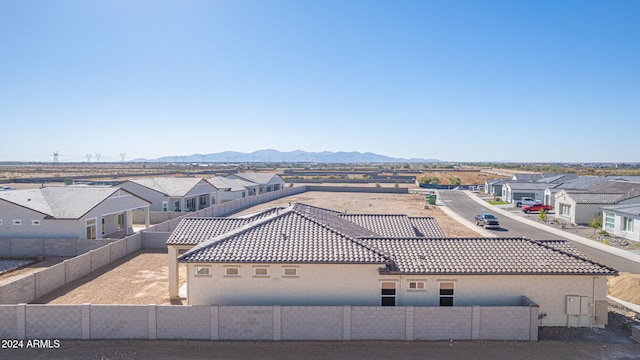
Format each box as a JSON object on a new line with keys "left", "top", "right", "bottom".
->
{"left": 0, "top": 0, "right": 640, "bottom": 162}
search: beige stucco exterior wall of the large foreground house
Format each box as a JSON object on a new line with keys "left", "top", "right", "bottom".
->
{"left": 187, "top": 264, "right": 607, "bottom": 326}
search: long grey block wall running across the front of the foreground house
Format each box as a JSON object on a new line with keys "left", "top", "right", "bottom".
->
{"left": 0, "top": 302, "right": 538, "bottom": 341}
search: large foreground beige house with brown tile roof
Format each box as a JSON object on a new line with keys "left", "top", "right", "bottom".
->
{"left": 168, "top": 204, "right": 617, "bottom": 326}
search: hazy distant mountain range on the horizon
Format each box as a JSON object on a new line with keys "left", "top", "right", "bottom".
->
{"left": 133, "top": 149, "right": 442, "bottom": 163}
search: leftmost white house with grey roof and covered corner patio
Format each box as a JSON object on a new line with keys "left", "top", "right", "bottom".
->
{"left": 0, "top": 186, "right": 150, "bottom": 239}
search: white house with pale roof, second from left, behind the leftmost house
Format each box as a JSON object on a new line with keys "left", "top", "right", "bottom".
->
{"left": 119, "top": 177, "right": 217, "bottom": 212}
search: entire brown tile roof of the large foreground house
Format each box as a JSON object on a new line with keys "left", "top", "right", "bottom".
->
{"left": 170, "top": 204, "right": 616, "bottom": 275}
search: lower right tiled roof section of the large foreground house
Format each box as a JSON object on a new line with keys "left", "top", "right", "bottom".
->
{"left": 360, "top": 238, "right": 617, "bottom": 275}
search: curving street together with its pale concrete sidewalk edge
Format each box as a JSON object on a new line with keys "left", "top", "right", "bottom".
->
{"left": 438, "top": 190, "right": 640, "bottom": 274}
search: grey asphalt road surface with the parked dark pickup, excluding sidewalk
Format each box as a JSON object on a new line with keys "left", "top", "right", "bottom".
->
{"left": 438, "top": 190, "right": 640, "bottom": 274}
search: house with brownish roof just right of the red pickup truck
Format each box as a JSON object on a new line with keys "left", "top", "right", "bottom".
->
{"left": 554, "top": 181, "right": 640, "bottom": 224}
